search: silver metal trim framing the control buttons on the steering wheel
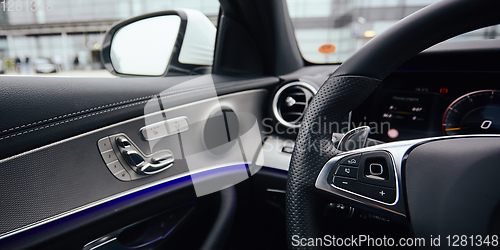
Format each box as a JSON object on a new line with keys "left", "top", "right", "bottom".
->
{"left": 315, "top": 134, "right": 500, "bottom": 216}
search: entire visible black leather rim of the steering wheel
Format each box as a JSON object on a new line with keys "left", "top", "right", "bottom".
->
{"left": 286, "top": 0, "right": 500, "bottom": 249}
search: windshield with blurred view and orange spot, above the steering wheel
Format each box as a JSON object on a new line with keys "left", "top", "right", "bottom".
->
{"left": 287, "top": 0, "right": 500, "bottom": 63}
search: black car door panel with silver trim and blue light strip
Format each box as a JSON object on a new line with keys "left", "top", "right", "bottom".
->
{"left": 0, "top": 75, "right": 278, "bottom": 248}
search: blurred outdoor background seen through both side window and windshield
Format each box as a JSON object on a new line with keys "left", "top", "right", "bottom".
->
{"left": 0, "top": 0, "right": 500, "bottom": 77}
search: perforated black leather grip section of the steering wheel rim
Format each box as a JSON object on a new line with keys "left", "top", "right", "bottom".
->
{"left": 286, "top": 76, "right": 379, "bottom": 249}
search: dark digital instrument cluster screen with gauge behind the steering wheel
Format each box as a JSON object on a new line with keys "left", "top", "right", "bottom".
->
{"left": 351, "top": 72, "right": 500, "bottom": 142}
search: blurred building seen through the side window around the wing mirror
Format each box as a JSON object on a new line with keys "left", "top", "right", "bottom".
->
{"left": 0, "top": 0, "right": 219, "bottom": 70}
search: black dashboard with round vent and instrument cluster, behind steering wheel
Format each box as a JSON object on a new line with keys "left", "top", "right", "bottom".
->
{"left": 259, "top": 40, "right": 500, "bottom": 174}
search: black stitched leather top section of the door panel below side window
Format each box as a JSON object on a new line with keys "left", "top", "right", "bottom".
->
{"left": 0, "top": 75, "right": 278, "bottom": 159}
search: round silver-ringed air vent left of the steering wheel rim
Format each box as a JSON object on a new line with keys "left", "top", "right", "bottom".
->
{"left": 273, "top": 82, "right": 316, "bottom": 128}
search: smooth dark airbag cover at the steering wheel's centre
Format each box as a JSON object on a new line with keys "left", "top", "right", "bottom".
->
{"left": 403, "top": 137, "right": 500, "bottom": 239}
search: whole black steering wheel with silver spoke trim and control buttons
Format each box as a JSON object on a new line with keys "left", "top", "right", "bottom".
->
{"left": 286, "top": 0, "right": 500, "bottom": 249}
